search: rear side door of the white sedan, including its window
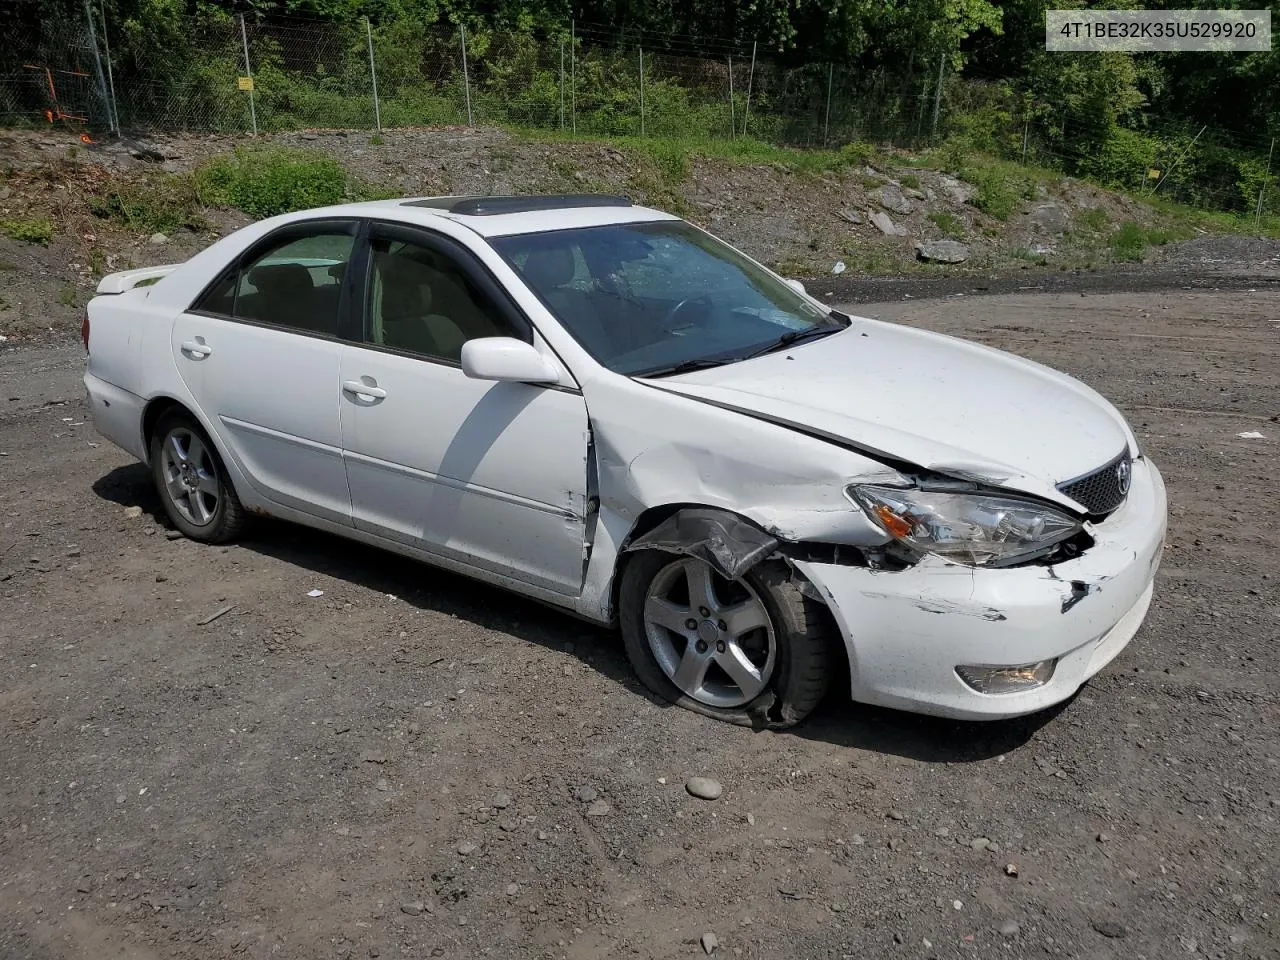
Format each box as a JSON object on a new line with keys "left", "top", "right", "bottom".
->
{"left": 173, "top": 219, "right": 360, "bottom": 525}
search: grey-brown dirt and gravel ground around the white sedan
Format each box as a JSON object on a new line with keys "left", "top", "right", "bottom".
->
{"left": 0, "top": 288, "right": 1280, "bottom": 960}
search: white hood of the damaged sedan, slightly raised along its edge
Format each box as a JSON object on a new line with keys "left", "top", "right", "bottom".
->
{"left": 646, "top": 317, "right": 1137, "bottom": 506}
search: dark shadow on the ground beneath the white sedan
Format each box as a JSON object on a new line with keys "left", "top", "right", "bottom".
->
{"left": 93, "top": 463, "right": 1070, "bottom": 763}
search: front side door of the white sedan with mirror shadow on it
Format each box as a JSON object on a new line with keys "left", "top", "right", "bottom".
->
{"left": 340, "top": 224, "right": 588, "bottom": 596}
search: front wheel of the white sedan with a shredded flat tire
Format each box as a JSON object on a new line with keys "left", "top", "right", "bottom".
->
{"left": 620, "top": 550, "right": 831, "bottom": 727}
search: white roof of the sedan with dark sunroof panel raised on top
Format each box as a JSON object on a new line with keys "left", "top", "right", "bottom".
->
{"left": 280, "top": 193, "right": 680, "bottom": 237}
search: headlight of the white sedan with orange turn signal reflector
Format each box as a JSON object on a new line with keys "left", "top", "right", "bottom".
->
{"left": 847, "top": 484, "right": 1082, "bottom": 567}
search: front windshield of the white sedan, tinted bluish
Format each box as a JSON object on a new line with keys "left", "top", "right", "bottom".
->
{"left": 490, "top": 220, "right": 846, "bottom": 375}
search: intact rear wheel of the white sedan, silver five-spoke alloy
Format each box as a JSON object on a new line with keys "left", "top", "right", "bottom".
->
{"left": 151, "top": 411, "right": 244, "bottom": 543}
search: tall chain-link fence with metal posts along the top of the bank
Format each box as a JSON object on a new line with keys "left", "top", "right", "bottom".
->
{"left": 0, "top": 8, "right": 1280, "bottom": 216}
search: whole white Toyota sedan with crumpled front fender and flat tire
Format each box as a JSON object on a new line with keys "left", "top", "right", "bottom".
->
{"left": 83, "top": 196, "right": 1166, "bottom": 726}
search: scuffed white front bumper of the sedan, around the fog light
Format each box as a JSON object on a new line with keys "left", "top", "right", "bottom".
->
{"left": 796, "top": 458, "right": 1167, "bottom": 719}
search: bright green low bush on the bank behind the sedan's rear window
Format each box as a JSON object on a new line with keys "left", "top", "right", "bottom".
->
{"left": 196, "top": 147, "right": 348, "bottom": 218}
